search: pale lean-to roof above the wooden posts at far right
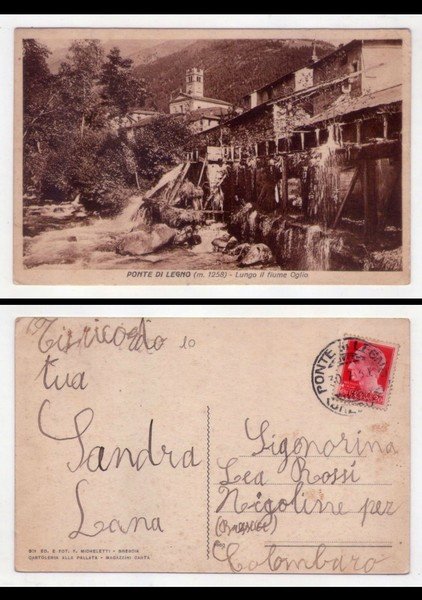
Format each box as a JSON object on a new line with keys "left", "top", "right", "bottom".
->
{"left": 304, "top": 84, "right": 402, "bottom": 125}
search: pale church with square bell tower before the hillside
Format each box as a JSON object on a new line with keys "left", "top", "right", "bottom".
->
{"left": 169, "top": 67, "right": 232, "bottom": 115}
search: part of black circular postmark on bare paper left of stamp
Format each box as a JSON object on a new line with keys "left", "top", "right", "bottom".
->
{"left": 312, "top": 337, "right": 362, "bottom": 416}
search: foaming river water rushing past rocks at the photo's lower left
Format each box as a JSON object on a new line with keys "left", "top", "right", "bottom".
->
{"left": 24, "top": 196, "right": 236, "bottom": 270}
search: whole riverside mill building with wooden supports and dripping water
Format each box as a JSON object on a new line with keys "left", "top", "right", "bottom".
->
{"left": 185, "top": 39, "right": 403, "bottom": 270}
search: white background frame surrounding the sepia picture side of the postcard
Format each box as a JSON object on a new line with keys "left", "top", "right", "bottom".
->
{"left": 0, "top": 15, "right": 422, "bottom": 298}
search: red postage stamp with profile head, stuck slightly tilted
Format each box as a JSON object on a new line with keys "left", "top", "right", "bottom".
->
{"left": 335, "top": 338, "right": 396, "bottom": 406}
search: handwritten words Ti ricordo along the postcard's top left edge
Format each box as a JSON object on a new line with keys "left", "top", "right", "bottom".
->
{"left": 26, "top": 317, "right": 167, "bottom": 354}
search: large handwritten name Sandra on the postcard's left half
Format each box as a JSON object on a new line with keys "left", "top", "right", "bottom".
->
{"left": 38, "top": 400, "right": 202, "bottom": 473}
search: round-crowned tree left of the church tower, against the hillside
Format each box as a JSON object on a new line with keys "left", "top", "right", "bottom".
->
{"left": 100, "top": 47, "right": 146, "bottom": 117}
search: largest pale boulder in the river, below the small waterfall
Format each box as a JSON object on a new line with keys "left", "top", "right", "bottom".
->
{"left": 116, "top": 223, "right": 177, "bottom": 256}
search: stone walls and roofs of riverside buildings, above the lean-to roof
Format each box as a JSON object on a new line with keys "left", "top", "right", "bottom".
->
{"left": 198, "top": 39, "right": 402, "bottom": 154}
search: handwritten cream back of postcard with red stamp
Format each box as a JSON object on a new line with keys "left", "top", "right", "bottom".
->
{"left": 15, "top": 315, "right": 410, "bottom": 575}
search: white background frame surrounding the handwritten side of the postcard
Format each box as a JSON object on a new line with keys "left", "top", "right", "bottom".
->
{"left": 0, "top": 305, "right": 422, "bottom": 587}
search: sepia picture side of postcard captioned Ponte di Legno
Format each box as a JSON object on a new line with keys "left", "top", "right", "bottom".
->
{"left": 14, "top": 28, "right": 411, "bottom": 285}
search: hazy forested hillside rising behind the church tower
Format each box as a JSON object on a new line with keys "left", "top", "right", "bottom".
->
{"left": 134, "top": 39, "right": 334, "bottom": 111}
